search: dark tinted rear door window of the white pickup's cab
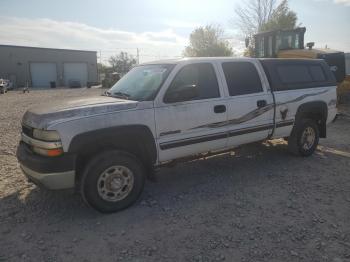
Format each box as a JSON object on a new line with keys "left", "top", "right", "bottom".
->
{"left": 222, "top": 62, "right": 263, "bottom": 96}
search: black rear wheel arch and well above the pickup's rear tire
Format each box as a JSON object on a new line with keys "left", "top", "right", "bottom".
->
{"left": 295, "top": 101, "right": 328, "bottom": 138}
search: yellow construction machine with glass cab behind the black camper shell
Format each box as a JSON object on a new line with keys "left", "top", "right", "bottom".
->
{"left": 250, "top": 27, "right": 350, "bottom": 100}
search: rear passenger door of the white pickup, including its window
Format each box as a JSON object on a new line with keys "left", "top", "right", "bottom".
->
{"left": 219, "top": 60, "right": 274, "bottom": 147}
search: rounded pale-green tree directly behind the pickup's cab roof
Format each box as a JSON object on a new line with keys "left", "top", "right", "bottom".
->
{"left": 183, "top": 25, "right": 233, "bottom": 57}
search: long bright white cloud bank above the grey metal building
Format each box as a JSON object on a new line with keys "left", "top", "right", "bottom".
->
{"left": 0, "top": 16, "right": 188, "bottom": 62}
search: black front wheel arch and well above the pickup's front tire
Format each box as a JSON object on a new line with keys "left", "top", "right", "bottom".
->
{"left": 68, "top": 125, "right": 157, "bottom": 185}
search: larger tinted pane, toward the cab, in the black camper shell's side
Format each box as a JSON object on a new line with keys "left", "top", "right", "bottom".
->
{"left": 277, "top": 65, "right": 312, "bottom": 84}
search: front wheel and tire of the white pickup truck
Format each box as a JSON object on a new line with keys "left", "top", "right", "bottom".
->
{"left": 81, "top": 151, "right": 145, "bottom": 213}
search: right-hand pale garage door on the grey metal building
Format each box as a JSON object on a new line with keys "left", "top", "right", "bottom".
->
{"left": 63, "top": 63, "right": 88, "bottom": 86}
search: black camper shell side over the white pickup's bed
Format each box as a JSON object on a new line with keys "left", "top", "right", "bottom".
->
{"left": 260, "top": 59, "right": 336, "bottom": 91}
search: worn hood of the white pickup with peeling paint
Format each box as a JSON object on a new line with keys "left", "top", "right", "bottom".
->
{"left": 22, "top": 96, "right": 138, "bottom": 129}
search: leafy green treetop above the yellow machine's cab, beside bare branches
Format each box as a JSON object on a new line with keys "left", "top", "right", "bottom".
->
{"left": 259, "top": 0, "right": 298, "bottom": 32}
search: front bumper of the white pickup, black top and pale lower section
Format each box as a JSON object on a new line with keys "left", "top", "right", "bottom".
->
{"left": 17, "top": 142, "right": 76, "bottom": 190}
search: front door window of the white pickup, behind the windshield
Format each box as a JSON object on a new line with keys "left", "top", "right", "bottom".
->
{"left": 164, "top": 63, "right": 220, "bottom": 103}
